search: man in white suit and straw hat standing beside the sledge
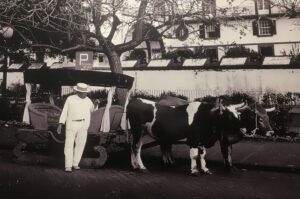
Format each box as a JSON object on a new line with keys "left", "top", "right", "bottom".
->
{"left": 57, "top": 83, "right": 94, "bottom": 172}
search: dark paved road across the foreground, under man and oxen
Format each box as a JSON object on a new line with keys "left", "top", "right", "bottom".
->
{"left": 0, "top": 148, "right": 300, "bottom": 199}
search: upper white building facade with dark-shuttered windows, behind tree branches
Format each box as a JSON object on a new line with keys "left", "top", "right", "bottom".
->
{"left": 127, "top": 0, "right": 300, "bottom": 61}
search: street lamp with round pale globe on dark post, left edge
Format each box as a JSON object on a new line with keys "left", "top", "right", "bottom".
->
{"left": 0, "top": 26, "right": 14, "bottom": 97}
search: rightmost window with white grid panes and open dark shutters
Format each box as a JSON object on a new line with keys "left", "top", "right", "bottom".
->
{"left": 252, "top": 18, "right": 276, "bottom": 36}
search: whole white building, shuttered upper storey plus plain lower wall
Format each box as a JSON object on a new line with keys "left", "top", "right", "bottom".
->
{"left": 118, "top": 0, "right": 300, "bottom": 99}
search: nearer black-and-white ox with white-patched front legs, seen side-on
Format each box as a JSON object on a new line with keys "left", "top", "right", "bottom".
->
{"left": 127, "top": 98, "right": 245, "bottom": 175}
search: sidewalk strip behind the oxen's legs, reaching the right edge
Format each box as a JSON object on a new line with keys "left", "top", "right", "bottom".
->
{"left": 144, "top": 136, "right": 300, "bottom": 173}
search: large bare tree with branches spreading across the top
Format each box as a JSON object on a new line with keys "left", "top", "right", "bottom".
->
{"left": 0, "top": 0, "right": 299, "bottom": 101}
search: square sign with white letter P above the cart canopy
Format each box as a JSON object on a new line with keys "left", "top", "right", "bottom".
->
{"left": 76, "top": 51, "right": 93, "bottom": 69}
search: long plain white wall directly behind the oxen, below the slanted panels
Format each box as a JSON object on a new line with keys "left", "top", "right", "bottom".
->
{"left": 124, "top": 69, "right": 300, "bottom": 100}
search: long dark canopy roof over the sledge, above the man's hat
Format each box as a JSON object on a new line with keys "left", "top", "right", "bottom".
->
{"left": 24, "top": 68, "right": 134, "bottom": 89}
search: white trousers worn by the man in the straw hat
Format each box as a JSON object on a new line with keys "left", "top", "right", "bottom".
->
{"left": 64, "top": 121, "right": 87, "bottom": 167}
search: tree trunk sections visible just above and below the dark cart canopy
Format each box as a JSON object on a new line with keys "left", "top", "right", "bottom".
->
{"left": 107, "top": 51, "right": 128, "bottom": 106}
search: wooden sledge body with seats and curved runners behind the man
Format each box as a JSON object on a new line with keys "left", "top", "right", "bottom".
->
{"left": 13, "top": 103, "right": 127, "bottom": 167}
